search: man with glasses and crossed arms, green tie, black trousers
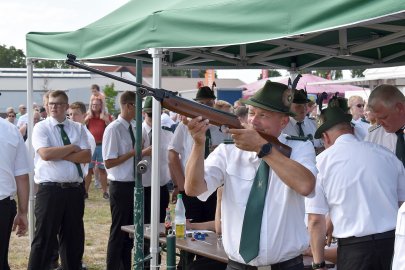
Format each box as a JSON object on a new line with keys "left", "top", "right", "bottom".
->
{"left": 28, "top": 90, "right": 91, "bottom": 270}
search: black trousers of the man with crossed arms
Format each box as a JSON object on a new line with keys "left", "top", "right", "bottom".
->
{"left": 28, "top": 184, "right": 84, "bottom": 270}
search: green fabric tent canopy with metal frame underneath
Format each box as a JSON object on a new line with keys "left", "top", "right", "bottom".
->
{"left": 27, "top": 0, "right": 405, "bottom": 69}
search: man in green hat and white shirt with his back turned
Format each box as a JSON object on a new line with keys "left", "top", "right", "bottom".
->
{"left": 306, "top": 108, "right": 405, "bottom": 270}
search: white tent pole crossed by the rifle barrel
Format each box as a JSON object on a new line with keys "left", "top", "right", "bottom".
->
{"left": 148, "top": 49, "right": 164, "bottom": 269}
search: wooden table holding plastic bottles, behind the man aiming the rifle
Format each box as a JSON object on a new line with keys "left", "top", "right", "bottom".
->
{"left": 121, "top": 224, "right": 334, "bottom": 269}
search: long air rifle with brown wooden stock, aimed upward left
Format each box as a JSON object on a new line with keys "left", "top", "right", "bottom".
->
{"left": 65, "top": 54, "right": 291, "bottom": 157}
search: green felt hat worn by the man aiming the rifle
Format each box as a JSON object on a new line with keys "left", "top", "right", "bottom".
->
{"left": 242, "top": 81, "right": 295, "bottom": 116}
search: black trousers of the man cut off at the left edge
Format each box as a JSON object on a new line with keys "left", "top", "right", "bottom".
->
{"left": 0, "top": 197, "right": 17, "bottom": 270}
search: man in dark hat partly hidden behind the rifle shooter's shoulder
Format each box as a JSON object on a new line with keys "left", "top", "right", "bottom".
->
{"left": 283, "top": 90, "right": 322, "bottom": 149}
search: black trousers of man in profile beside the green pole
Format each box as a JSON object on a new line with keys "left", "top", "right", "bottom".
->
{"left": 107, "top": 181, "right": 135, "bottom": 270}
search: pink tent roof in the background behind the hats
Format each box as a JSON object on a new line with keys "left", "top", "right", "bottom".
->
{"left": 240, "top": 74, "right": 368, "bottom": 98}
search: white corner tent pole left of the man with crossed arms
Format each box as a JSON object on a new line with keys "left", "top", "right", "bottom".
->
{"left": 27, "top": 58, "right": 35, "bottom": 243}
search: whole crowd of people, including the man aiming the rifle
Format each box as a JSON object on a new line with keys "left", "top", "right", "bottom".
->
{"left": 0, "top": 81, "right": 405, "bottom": 270}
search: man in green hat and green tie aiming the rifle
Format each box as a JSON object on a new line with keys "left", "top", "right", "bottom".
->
{"left": 183, "top": 81, "right": 316, "bottom": 270}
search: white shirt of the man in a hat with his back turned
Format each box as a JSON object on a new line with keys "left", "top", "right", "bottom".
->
{"left": 305, "top": 134, "right": 405, "bottom": 238}
